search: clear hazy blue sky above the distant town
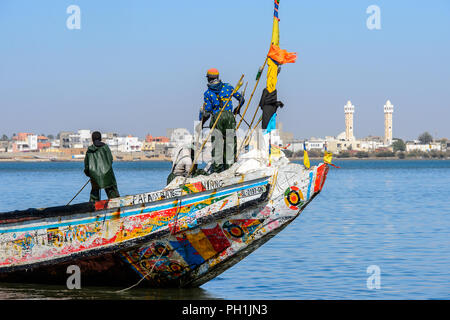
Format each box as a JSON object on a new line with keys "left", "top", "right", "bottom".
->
{"left": 0, "top": 0, "right": 450, "bottom": 139}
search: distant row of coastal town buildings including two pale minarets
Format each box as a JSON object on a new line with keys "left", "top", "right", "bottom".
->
{"left": 0, "top": 100, "right": 450, "bottom": 162}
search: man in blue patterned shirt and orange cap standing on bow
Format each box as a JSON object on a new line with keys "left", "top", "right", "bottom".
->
{"left": 199, "top": 68, "right": 245, "bottom": 172}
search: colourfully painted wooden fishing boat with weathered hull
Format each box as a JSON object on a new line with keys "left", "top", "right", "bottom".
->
{"left": 0, "top": 157, "right": 328, "bottom": 287}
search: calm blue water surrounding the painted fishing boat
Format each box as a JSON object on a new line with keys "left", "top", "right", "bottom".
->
{"left": 0, "top": 160, "right": 450, "bottom": 299}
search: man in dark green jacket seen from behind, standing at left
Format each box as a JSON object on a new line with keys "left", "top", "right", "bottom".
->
{"left": 84, "top": 131, "right": 120, "bottom": 202}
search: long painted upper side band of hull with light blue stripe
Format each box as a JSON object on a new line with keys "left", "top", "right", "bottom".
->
{"left": 0, "top": 179, "right": 267, "bottom": 270}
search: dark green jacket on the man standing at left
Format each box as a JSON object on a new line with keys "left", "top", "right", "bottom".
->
{"left": 84, "top": 141, "right": 117, "bottom": 189}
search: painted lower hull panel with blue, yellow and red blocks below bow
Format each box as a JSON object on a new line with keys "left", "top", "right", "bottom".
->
{"left": 118, "top": 167, "right": 327, "bottom": 285}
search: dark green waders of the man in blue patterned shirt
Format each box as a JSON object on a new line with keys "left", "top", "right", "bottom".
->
{"left": 209, "top": 110, "right": 237, "bottom": 172}
